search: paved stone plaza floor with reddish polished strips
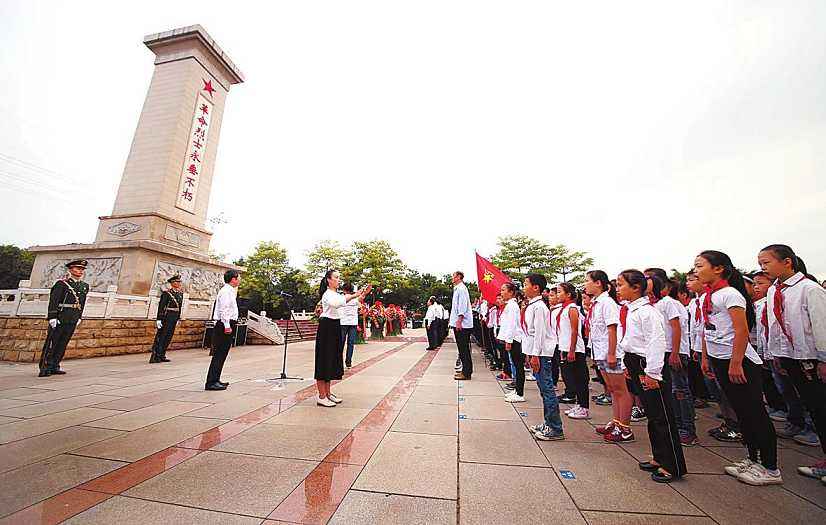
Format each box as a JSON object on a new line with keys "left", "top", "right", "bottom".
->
{"left": 0, "top": 331, "right": 826, "bottom": 525}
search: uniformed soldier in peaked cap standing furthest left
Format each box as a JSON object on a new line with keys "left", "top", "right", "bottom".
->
{"left": 39, "top": 259, "right": 89, "bottom": 377}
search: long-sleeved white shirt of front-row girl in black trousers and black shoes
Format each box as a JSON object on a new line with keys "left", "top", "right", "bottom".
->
{"left": 617, "top": 296, "right": 666, "bottom": 381}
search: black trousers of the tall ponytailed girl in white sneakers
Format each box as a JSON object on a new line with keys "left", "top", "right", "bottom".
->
{"left": 708, "top": 356, "right": 777, "bottom": 470}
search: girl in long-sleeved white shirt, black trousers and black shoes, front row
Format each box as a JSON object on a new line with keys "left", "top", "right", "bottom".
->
{"left": 617, "top": 270, "right": 686, "bottom": 483}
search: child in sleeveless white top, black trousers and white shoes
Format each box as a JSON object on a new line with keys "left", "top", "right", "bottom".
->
{"left": 552, "top": 283, "right": 591, "bottom": 419}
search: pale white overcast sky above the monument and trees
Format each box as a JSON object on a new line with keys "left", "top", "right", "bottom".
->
{"left": 0, "top": 0, "right": 826, "bottom": 279}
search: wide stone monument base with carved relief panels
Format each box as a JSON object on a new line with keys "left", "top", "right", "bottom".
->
{"left": 29, "top": 240, "right": 243, "bottom": 301}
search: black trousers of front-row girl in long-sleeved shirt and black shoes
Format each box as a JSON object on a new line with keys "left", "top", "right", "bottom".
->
{"left": 623, "top": 354, "right": 686, "bottom": 478}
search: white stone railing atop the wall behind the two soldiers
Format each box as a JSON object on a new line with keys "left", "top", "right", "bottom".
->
{"left": 0, "top": 281, "right": 213, "bottom": 320}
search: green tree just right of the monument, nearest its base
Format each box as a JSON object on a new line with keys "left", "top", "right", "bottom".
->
{"left": 236, "top": 241, "right": 291, "bottom": 312}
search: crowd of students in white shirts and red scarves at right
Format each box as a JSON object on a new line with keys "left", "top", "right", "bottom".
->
{"left": 466, "top": 244, "right": 826, "bottom": 485}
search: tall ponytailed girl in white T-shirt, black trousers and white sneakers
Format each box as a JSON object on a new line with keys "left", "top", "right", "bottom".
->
{"left": 694, "top": 250, "right": 783, "bottom": 485}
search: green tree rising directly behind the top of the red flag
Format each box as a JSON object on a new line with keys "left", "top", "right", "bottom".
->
{"left": 491, "top": 235, "right": 559, "bottom": 282}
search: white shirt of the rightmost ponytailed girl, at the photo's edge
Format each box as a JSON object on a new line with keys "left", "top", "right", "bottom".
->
{"left": 758, "top": 272, "right": 826, "bottom": 362}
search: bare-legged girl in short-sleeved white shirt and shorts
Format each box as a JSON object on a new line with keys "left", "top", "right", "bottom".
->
{"left": 585, "top": 270, "right": 634, "bottom": 443}
